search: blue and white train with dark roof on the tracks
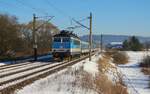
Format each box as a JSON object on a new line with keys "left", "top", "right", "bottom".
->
{"left": 52, "top": 30, "right": 95, "bottom": 60}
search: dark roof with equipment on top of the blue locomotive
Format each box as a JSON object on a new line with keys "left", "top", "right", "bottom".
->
{"left": 54, "top": 30, "right": 79, "bottom": 39}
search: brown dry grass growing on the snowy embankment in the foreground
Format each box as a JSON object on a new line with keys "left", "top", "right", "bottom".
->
{"left": 64, "top": 56, "right": 128, "bottom": 94}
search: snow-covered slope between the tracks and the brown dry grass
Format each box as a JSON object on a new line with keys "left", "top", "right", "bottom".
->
{"left": 16, "top": 53, "right": 99, "bottom": 94}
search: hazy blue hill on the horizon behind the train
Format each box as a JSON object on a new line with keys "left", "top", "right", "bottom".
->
{"left": 80, "top": 35, "right": 150, "bottom": 44}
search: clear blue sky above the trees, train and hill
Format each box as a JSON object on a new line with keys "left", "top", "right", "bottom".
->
{"left": 0, "top": 0, "right": 150, "bottom": 36}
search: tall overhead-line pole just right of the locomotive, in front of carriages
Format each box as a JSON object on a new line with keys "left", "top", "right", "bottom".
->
{"left": 89, "top": 13, "right": 92, "bottom": 61}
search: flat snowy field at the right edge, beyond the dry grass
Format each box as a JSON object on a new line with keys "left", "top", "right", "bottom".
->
{"left": 119, "top": 51, "right": 150, "bottom": 94}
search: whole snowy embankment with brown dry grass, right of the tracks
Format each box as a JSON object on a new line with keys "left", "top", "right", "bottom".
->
{"left": 16, "top": 54, "right": 128, "bottom": 94}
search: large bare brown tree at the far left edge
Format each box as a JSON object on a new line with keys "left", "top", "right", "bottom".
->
{"left": 0, "top": 14, "right": 22, "bottom": 55}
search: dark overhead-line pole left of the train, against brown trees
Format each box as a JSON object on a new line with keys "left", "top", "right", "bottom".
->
{"left": 32, "top": 14, "right": 37, "bottom": 61}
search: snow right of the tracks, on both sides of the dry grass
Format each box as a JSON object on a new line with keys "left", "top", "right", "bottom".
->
{"left": 3, "top": 51, "right": 150, "bottom": 94}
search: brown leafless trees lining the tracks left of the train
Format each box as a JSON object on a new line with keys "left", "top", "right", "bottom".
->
{"left": 0, "top": 14, "right": 59, "bottom": 59}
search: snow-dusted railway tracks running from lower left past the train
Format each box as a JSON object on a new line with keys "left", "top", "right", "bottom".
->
{"left": 0, "top": 53, "right": 94, "bottom": 94}
